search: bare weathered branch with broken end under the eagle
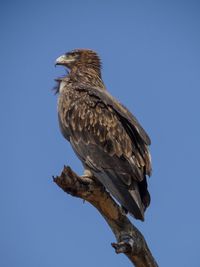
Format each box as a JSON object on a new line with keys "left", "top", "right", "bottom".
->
{"left": 54, "top": 167, "right": 158, "bottom": 267}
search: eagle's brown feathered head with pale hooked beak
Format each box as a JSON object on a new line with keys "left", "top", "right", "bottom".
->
{"left": 55, "top": 49, "right": 101, "bottom": 71}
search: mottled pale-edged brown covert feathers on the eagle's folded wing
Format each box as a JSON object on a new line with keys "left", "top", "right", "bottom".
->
{"left": 67, "top": 92, "right": 148, "bottom": 181}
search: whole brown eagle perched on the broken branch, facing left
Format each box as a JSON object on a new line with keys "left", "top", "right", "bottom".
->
{"left": 55, "top": 49, "right": 152, "bottom": 221}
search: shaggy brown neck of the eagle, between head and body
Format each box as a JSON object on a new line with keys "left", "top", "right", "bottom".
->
{"left": 68, "top": 67, "right": 105, "bottom": 89}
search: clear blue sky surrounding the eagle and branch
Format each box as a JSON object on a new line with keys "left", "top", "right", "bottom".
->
{"left": 0, "top": 0, "right": 200, "bottom": 267}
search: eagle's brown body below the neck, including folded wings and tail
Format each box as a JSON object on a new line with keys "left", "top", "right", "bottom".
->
{"left": 58, "top": 85, "right": 151, "bottom": 220}
